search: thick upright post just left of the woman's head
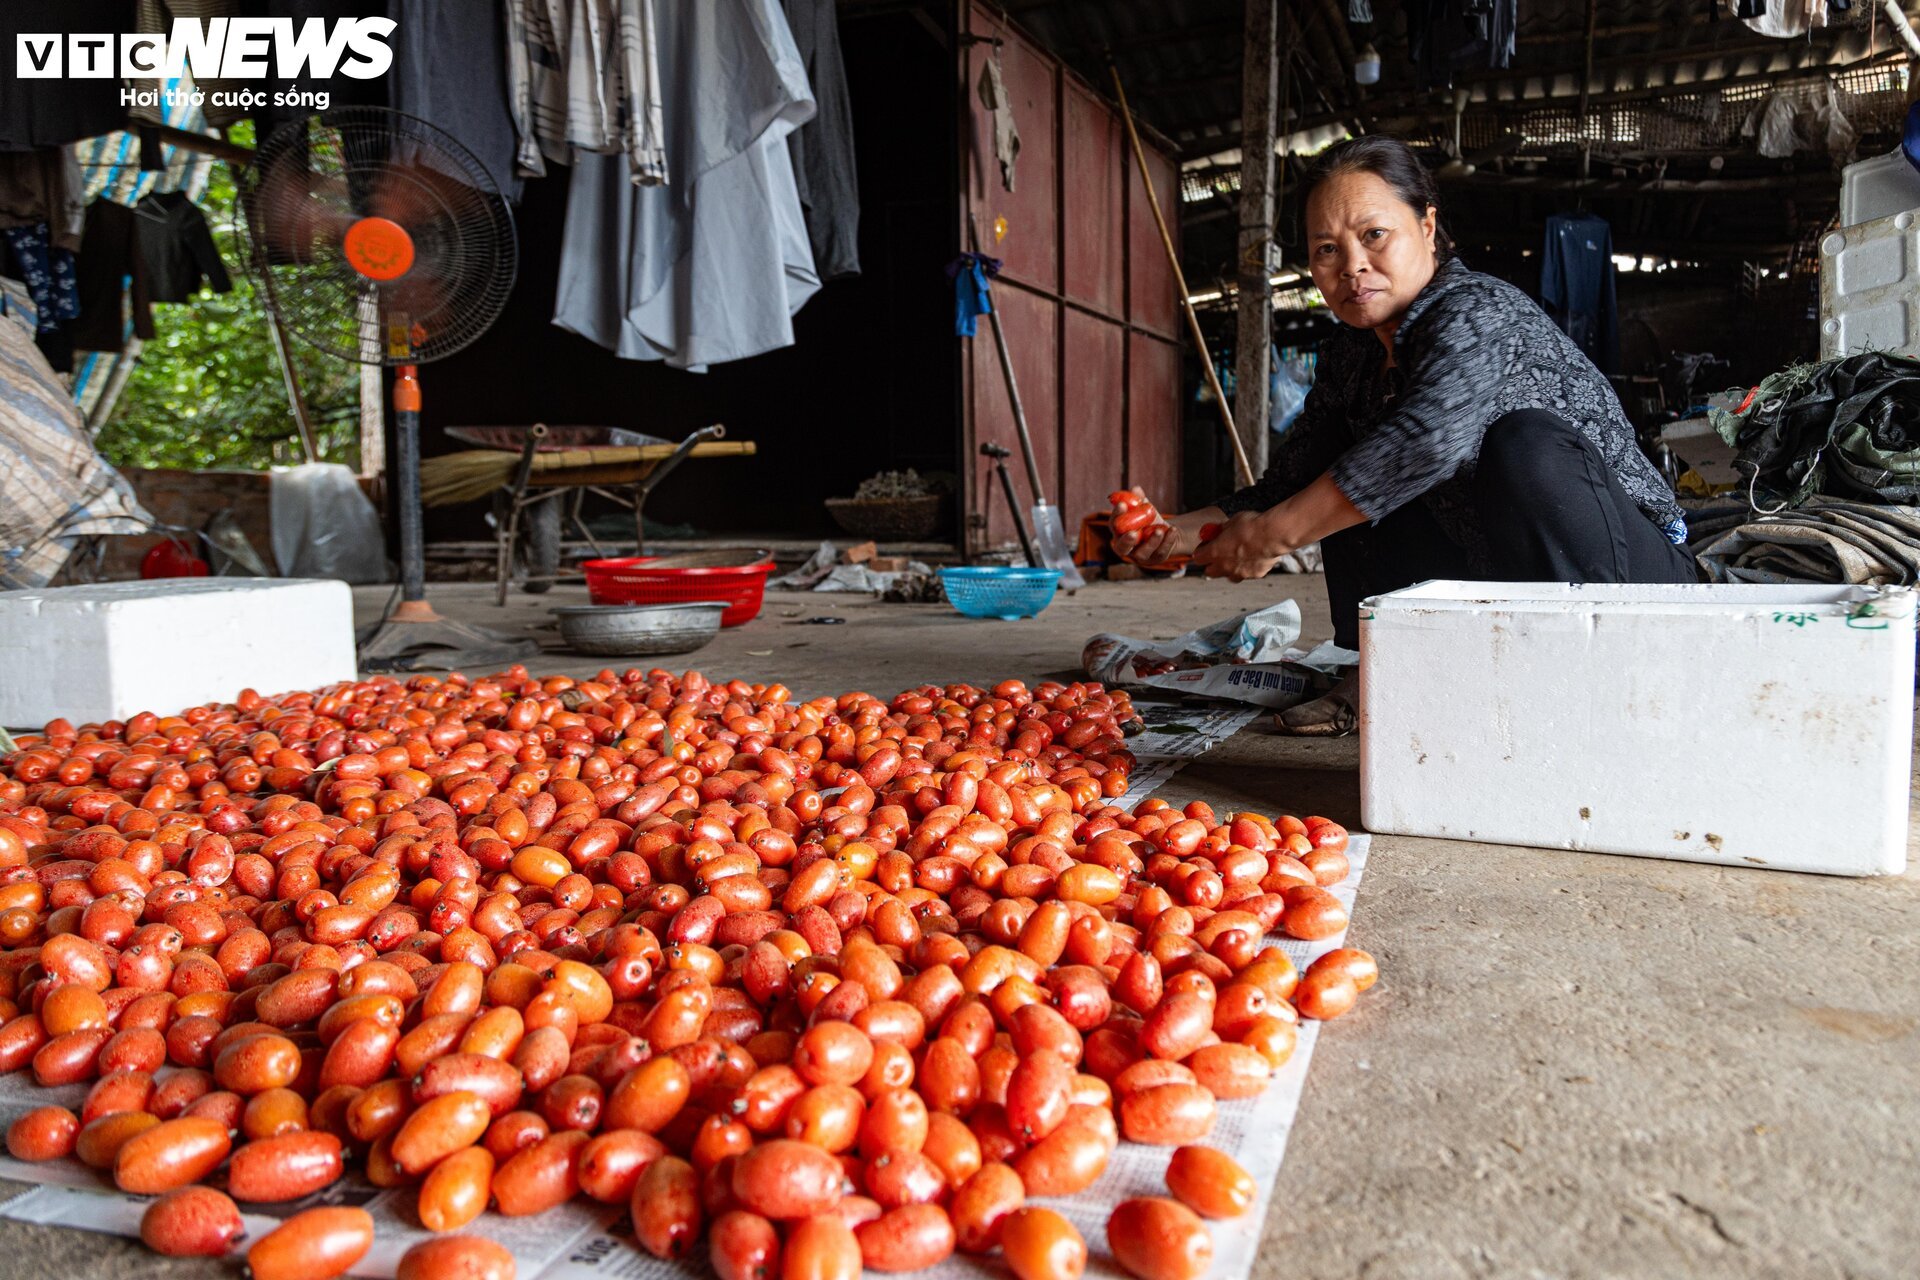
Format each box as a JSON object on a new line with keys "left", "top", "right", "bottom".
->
{"left": 1233, "top": 0, "right": 1279, "bottom": 483}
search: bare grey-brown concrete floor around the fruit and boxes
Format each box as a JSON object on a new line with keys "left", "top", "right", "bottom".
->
{"left": 0, "top": 578, "right": 1920, "bottom": 1280}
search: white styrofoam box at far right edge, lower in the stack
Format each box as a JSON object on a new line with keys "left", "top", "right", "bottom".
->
{"left": 1820, "top": 209, "right": 1920, "bottom": 361}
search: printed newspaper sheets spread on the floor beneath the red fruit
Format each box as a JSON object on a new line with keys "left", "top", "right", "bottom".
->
{"left": 0, "top": 721, "right": 1367, "bottom": 1280}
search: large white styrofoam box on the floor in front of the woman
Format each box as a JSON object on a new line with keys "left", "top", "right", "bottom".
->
{"left": 1359, "top": 581, "right": 1914, "bottom": 875}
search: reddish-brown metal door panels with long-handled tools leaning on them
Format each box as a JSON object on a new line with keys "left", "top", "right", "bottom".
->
{"left": 960, "top": 4, "right": 1181, "bottom": 551}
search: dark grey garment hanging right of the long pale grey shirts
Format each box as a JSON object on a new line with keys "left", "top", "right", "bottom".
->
{"left": 787, "top": 0, "right": 860, "bottom": 280}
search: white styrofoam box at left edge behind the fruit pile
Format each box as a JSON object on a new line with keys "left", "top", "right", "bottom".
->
{"left": 0, "top": 578, "right": 353, "bottom": 729}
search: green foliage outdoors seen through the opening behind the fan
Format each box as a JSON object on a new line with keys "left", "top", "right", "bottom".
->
{"left": 98, "top": 127, "right": 361, "bottom": 470}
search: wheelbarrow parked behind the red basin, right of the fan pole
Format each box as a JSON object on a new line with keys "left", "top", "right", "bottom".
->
{"left": 432, "top": 422, "right": 755, "bottom": 604}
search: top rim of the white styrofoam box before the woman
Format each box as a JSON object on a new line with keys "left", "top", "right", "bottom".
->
{"left": 1361, "top": 580, "right": 1914, "bottom": 618}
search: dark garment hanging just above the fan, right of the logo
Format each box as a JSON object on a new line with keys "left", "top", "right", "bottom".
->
{"left": 385, "top": 0, "right": 520, "bottom": 201}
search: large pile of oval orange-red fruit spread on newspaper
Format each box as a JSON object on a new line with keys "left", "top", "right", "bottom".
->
{"left": 0, "top": 668, "right": 1375, "bottom": 1280}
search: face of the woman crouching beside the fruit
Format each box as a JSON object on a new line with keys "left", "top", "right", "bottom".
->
{"left": 1308, "top": 173, "right": 1436, "bottom": 328}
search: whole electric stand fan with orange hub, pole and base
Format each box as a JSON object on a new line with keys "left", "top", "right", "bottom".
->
{"left": 238, "top": 107, "right": 540, "bottom": 672}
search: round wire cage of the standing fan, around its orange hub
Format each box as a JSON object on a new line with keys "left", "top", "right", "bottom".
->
{"left": 236, "top": 107, "right": 518, "bottom": 365}
